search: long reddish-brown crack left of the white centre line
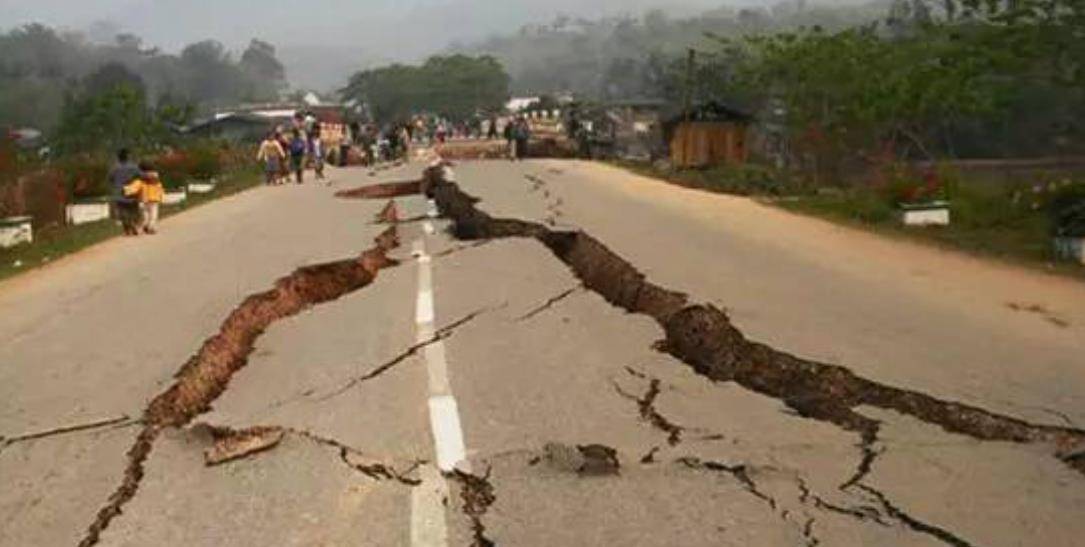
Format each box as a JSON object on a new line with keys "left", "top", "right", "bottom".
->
{"left": 79, "top": 227, "right": 399, "bottom": 547}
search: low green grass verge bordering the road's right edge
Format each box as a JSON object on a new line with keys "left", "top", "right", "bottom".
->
{"left": 613, "top": 162, "right": 1085, "bottom": 279}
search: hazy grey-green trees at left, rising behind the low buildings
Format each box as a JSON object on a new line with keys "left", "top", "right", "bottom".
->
{"left": 0, "top": 24, "right": 286, "bottom": 145}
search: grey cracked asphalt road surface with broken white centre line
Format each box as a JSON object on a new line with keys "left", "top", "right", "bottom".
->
{"left": 0, "top": 161, "right": 1085, "bottom": 546}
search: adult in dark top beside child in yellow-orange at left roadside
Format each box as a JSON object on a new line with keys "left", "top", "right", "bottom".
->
{"left": 110, "top": 149, "right": 166, "bottom": 236}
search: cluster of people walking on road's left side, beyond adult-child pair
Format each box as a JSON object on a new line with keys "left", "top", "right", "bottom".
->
{"left": 256, "top": 112, "right": 326, "bottom": 186}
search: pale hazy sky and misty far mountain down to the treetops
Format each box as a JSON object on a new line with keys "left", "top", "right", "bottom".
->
{"left": 0, "top": 0, "right": 798, "bottom": 89}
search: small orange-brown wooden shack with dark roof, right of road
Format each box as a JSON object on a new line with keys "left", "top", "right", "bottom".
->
{"left": 666, "top": 102, "right": 752, "bottom": 167}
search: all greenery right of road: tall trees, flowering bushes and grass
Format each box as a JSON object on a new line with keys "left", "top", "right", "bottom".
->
{"left": 581, "top": 0, "right": 1085, "bottom": 274}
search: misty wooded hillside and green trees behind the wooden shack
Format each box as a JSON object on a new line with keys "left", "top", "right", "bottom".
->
{"left": 457, "top": 0, "right": 1085, "bottom": 170}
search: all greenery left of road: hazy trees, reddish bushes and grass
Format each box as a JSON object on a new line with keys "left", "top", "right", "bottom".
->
{"left": 0, "top": 25, "right": 285, "bottom": 279}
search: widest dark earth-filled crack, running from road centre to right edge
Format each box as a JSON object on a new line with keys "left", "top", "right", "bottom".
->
{"left": 420, "top": 172, "right": 1085, "bottom": 474}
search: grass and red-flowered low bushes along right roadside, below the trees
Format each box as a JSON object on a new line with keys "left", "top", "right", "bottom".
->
{"left": 614, "top": 161, "right": 1085, "bottom": 277}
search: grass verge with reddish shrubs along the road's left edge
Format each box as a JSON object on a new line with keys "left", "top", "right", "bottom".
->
{"left": 0, "top": 170, "right": 263, "bottom": 280}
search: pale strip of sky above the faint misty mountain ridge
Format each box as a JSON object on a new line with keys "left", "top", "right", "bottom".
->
{"left": 0, "top": 0, "right": 757, "bottom": 49}
